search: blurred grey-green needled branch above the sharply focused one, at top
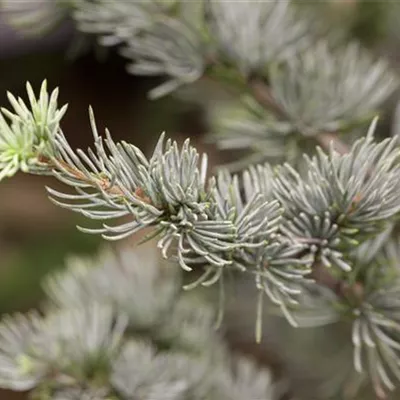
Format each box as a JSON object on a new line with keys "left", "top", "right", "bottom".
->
{"left": 3, "top": 0, "right": 398, "bottom": 169}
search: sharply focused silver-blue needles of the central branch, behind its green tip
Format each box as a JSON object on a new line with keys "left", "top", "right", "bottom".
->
{"left": 1, "top": 82, "right": 400, "bottom": 344}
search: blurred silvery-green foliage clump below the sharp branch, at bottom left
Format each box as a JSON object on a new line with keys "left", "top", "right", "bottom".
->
{"left": 0, "top": 242, "right": 274, "bottom": 400}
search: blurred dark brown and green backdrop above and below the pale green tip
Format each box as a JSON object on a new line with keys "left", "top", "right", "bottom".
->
{"left": 0, "top": 15, "right": 212, "bottom": 318}
